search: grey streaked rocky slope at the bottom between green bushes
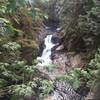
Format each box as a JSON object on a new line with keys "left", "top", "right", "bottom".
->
{"left": 52, "top": 81, "right": 84, "bottom": 100}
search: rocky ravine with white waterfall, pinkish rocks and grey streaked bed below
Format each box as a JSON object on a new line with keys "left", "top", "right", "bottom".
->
{"left": 37, "top": 27, "right": 84, "bottom": 100}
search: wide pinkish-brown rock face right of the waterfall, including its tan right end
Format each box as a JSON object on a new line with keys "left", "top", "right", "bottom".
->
{"left": 52, "top": 49, "right": 85, "bottom": 75}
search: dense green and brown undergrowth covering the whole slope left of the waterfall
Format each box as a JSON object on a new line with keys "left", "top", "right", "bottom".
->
{"left": 0, "top": 0, "right": 53, "bottom": 100}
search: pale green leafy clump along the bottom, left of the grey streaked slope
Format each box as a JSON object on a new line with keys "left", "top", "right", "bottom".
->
{"left": 9, "top": 78, "right": 53, "bottom": 100}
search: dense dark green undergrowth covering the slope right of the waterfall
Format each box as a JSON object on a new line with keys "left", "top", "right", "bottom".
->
{"left": 57, "top": 0, "right": 100, "bottom": 100}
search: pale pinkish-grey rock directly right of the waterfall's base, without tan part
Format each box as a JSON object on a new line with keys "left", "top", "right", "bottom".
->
{"left": 52, "top": 51, "right": 72, "bottom": 73}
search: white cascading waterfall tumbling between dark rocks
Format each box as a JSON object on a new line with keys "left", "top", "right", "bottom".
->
{"left": 37, "top": 35, "right": 55, "bottom": 66}
